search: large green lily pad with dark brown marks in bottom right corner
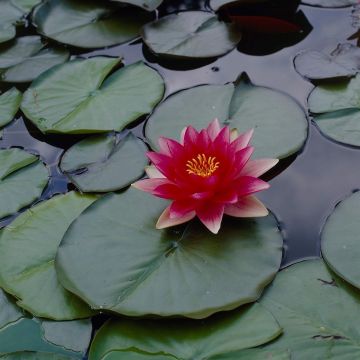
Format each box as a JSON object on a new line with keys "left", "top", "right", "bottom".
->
{"left": 260, "top": 260, "right": 360, "bottom": 360}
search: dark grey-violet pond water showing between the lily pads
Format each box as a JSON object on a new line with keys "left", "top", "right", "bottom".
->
{"left": 0, "top": 1, "right": 360, "bottom": 266}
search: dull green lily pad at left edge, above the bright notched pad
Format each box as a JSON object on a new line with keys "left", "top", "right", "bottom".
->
{"left": 0, "top": 36, "right": 70, "bottom": 83}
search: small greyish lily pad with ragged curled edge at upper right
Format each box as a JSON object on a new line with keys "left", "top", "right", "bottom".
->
{"left": 294, "top": 43, "right": 360, "bottom": 80}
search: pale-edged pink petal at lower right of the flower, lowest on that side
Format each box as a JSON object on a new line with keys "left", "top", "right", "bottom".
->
{"left": 224, "top": 195, "right": 269, "bottom": 217}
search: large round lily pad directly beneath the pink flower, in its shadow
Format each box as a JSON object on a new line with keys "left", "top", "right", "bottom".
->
{"left": 56, "top": 188, "right": 282, "bottom": 318}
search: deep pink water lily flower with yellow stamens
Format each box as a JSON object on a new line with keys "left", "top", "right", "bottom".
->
{"left": 132, "top": 119, "right": 278, "bottom": 234}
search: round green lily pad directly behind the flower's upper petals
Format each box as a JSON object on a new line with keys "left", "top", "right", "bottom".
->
{"left": 145, "top": 76, "right": 308, "bottom": 158}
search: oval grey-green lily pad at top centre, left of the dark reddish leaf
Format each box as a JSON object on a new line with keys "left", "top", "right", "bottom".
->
{"left": 142, "top": 11, "right": 241, "bottom": 58}
